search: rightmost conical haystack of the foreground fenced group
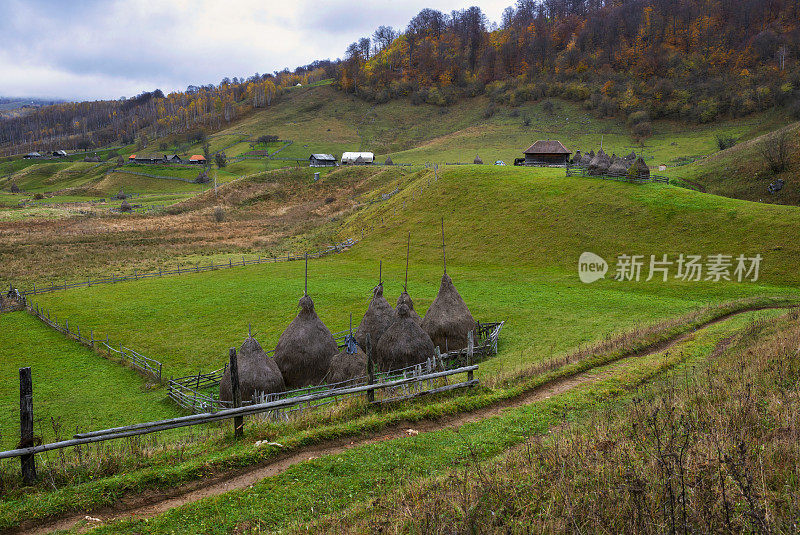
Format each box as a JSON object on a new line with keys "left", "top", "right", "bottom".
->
{"left": 422, "top": 273, "right": 476, "bottom": 352}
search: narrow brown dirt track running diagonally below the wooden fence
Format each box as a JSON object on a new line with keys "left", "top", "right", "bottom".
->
{"left": 18, "top": 306, "right": 791, "bottom": 534}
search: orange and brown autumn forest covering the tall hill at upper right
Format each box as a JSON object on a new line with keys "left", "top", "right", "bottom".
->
{"left": 338, "top": 0, "right": 800, "bottom": 129}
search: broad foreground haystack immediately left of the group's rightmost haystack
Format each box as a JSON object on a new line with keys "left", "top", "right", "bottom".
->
{"left": 375, "top": 304, "right": 434, "bottom": 371}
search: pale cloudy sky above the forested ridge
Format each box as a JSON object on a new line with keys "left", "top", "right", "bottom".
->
{"left": 0, "top": 0, "right": 514, "bottom": 100}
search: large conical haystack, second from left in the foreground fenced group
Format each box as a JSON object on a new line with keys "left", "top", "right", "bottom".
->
{"left": 275, "top": 295, "right": 339, "bottom": 388}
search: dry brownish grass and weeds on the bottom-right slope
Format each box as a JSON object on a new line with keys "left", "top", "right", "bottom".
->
{"left": 330, "top": 311, "right": 800, "bottom": 533}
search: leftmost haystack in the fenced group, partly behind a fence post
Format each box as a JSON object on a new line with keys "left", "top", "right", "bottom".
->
{"left": 219, "top": 336, "right": 286, "bottom": 401}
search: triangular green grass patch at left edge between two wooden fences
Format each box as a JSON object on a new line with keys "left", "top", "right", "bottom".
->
{"left": 0, "top": 312, "right": 179, "bottom": 449}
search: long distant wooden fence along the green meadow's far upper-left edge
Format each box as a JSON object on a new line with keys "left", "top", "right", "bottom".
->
{"left": 20, "top": 239, "right": 357, "bottom": 296}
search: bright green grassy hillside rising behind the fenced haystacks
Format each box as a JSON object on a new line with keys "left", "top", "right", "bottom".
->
{"left": 31, "top": 166, "right": 800, "bottom": 375}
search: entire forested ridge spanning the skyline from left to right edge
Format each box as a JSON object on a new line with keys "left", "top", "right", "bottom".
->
{"left": 0, "top": 0, "right": 800, "bottom": 154}
